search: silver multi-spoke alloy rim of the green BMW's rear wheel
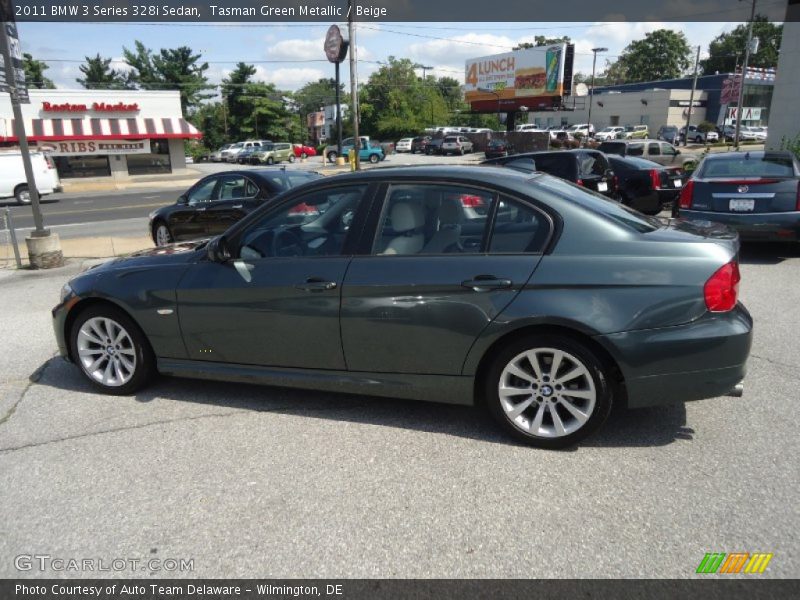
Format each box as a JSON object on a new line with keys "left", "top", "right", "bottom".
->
{"left": 497, "top": 348, "right": 597, "bottom": 439}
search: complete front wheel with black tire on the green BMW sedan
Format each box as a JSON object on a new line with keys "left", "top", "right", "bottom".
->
{"left": 69, "top": 304, "right": 156, "bottom": 396}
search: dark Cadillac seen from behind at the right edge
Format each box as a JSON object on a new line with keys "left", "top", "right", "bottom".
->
{"left": 679, "top": 151, "right": 800, "bottom": 242}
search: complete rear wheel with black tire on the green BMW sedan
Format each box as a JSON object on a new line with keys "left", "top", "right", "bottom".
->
{"left": 484, "top": 335, "right": 612, "bottom": 449}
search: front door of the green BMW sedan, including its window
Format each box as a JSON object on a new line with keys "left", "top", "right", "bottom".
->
{"left": 177, "top": 184, "right": 368, "bottom": 370}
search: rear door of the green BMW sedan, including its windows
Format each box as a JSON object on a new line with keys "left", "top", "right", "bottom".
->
{"left": 341, "top": 183, "right": 550, "bottom": 375}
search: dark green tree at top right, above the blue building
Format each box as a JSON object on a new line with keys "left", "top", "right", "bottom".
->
{"left": 700, "top": 15, "right": 783, "bottom": 75}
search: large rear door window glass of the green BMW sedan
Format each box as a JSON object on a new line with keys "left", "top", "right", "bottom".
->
{"left": 372, "top": 183, "right": 495, "bottom": 255}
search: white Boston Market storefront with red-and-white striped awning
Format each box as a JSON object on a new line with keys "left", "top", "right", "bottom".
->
{"left": 0, "top": 90, "right": 202, "bottom": 179}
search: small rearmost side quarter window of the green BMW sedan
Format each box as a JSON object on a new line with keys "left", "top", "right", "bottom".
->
{"left": 489, "top": 197, "right": 550, "bottom": 254}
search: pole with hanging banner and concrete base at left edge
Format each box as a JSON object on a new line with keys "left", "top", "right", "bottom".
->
{"left": 0, "top": 17, "right": 64, "bottom": 269}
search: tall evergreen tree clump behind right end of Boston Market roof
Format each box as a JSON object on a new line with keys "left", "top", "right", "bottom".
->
{"left": 122, "top": 40, "right": 213, "bottom": 113}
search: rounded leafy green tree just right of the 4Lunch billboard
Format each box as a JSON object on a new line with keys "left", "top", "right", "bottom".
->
{"left": 608, "top": 29, "right": 692, "bottom": 83}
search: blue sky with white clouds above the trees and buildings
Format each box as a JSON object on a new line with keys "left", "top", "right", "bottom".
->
{"left": 19, "top": 22, "right": 737, "bottom": 90}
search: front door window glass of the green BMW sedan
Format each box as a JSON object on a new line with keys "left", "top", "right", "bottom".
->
{"left": 239, "top": 185, "right": 367, "bottom": 260}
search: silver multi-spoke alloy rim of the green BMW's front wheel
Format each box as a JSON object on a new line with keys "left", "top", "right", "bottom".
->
{"left": 76, "top": 317, "right": 137, "bottom": 387}
